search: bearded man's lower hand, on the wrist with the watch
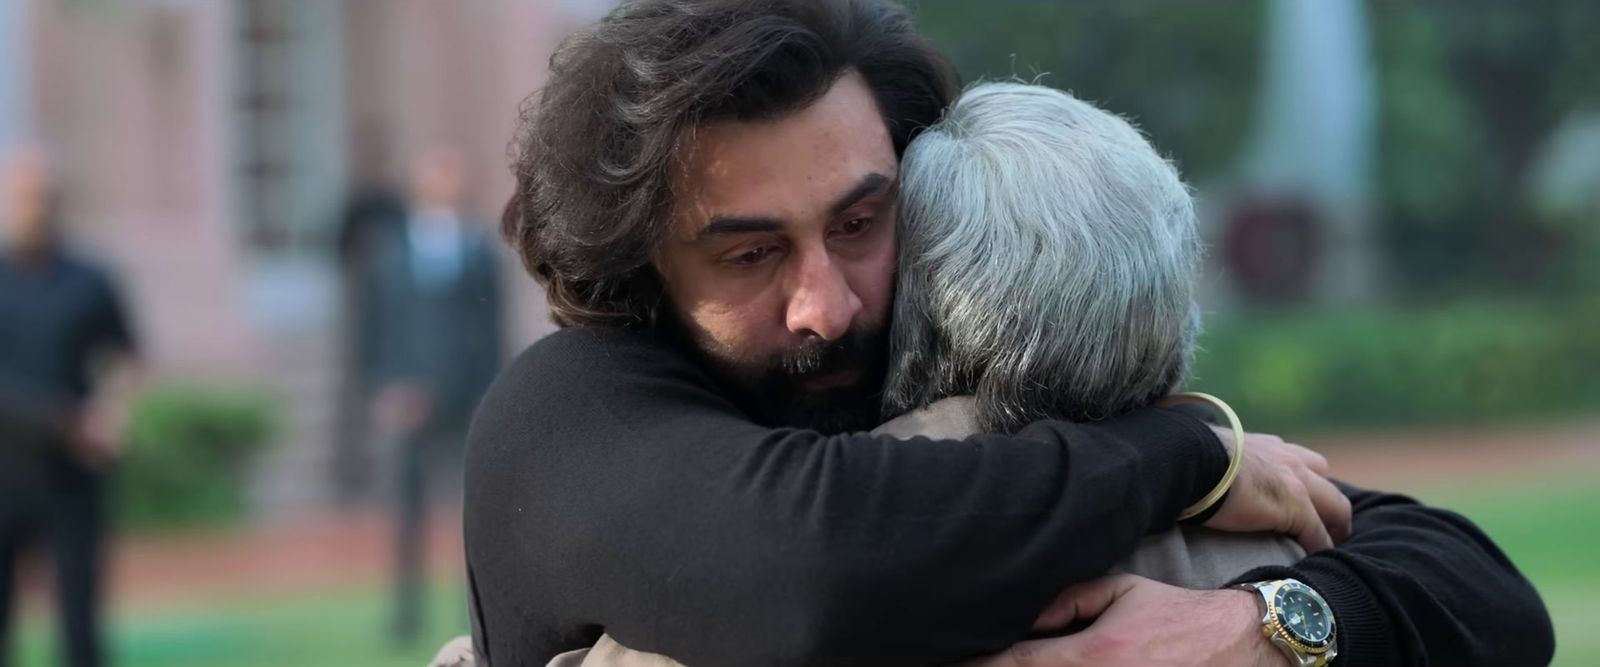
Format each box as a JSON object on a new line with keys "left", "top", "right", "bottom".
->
{"left": 965, "top": 574, "right": 1290, "bottom": 667}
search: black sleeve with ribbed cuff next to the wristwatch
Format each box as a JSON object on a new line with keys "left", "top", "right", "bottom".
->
{"left": 1237, "top": 485, "right": 1555, "bottom": 667}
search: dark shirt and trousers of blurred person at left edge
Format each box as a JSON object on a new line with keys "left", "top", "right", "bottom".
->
{"left": 0, "top": 254, "right": 134, "bottom": 665}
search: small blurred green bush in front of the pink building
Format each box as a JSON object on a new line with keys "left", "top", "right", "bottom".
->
{"left": 117, "top": 385, "right": 278, "bottom": 528}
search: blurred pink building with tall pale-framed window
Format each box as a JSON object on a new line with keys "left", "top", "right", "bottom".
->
{"left": 0, "top": 0, "right": 610, "bottom": 512}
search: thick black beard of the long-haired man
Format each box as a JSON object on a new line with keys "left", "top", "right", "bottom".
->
{"left": 662, "top": 311, "right": 888, "bottom": 433}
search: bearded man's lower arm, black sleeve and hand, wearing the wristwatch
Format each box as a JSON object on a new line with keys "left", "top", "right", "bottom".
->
{"left": 968, "top": 485, "right": 1555, "bottom": 667}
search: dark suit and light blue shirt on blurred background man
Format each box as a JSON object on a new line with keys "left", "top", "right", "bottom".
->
{"left": 362, "top": 211, "right": 501, "bottom": 640}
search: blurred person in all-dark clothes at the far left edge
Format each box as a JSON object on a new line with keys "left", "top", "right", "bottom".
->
{"left": 0, "top": 147, "right": 138, "bottom": 665}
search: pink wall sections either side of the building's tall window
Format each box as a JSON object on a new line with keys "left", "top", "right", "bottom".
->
{"left": 30, "top": 0, "right": 588, "bottom": 374}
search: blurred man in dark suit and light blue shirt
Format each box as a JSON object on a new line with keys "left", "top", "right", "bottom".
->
{"left": 360, "top": 146, "right": 501, "bottom": 643}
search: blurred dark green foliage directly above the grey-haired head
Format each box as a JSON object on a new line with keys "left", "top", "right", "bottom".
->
{"left": 912, "top": 0, "right": 1266, "bottom": 181}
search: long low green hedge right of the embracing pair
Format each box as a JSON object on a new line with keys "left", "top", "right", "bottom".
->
{"left": 1189, "top": 296, "right": 1600, "bottom": 430}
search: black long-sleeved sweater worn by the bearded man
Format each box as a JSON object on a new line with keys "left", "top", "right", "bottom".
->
{"left": 466, "top": 328, "right": 1554, "bottom": 667}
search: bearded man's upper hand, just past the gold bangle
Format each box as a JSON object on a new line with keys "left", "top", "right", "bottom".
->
{"left": 1205, "top": 429, "right": 1350, "bottom": 552}
